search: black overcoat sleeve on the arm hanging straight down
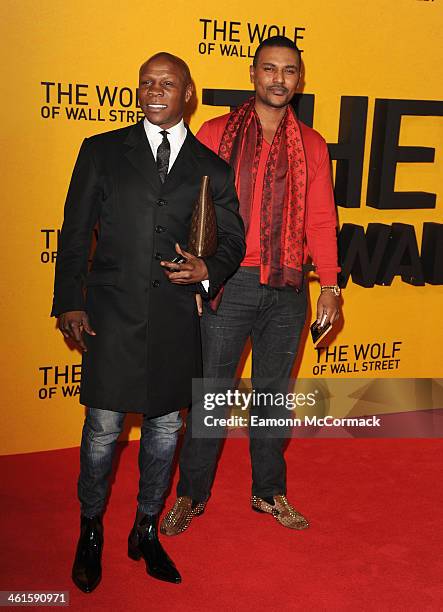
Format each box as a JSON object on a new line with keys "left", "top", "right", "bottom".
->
{"left": 51, "top": 138, "right": 101, "bottom": 317}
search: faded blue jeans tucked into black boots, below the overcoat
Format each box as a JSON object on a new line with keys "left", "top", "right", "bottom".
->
{"left": 78, "top": 408, "right": 182, "bottom": 518}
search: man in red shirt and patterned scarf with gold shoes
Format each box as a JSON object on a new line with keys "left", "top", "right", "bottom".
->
{"left": 161, "top": 36, "right": 340, "bottom": 535}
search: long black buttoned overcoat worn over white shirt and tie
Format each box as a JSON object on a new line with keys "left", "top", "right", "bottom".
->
{"left": 52, "top": 122, "right": 245, "bottom": 417}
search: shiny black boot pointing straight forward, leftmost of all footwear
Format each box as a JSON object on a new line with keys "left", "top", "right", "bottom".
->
{"left": 72, "top": 516, "right": 103, "bottom": 593}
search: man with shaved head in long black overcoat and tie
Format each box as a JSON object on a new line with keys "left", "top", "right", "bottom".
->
{"left": 52, "top": 53, "right": 245, "bottom": 592}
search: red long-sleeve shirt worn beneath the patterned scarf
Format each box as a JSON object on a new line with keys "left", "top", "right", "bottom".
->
{"left": 197, "top": 114, "right": 340, "bottom": 285}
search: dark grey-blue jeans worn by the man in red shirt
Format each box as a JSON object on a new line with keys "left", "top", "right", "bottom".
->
{"left": 177, "top": 268, "right": 306, "bottom": 502}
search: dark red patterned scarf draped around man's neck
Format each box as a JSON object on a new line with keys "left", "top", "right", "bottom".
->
{"left": 219, "top": 98, "right": 307, "bottom": 288}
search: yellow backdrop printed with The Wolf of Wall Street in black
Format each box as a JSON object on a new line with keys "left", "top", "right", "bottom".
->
{"left": 0, "top": 0, "right": 443, "bottom": 454}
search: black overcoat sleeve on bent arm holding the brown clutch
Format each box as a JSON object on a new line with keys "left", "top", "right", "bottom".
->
{"left": 203, "top": 167, "right": 246, "bottom": 299}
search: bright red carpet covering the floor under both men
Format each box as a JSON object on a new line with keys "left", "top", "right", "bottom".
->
{"left": 0, "top": 440, "right": 443, "bottom": 612}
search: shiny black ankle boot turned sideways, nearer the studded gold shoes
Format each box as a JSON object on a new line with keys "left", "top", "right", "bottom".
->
{"left": 128, "top": 512, "right": 182, "bottom": 584}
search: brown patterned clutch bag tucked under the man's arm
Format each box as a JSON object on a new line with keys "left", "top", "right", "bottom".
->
{"left": 188, "top": 176, "right": 217, "bottom": 257}
